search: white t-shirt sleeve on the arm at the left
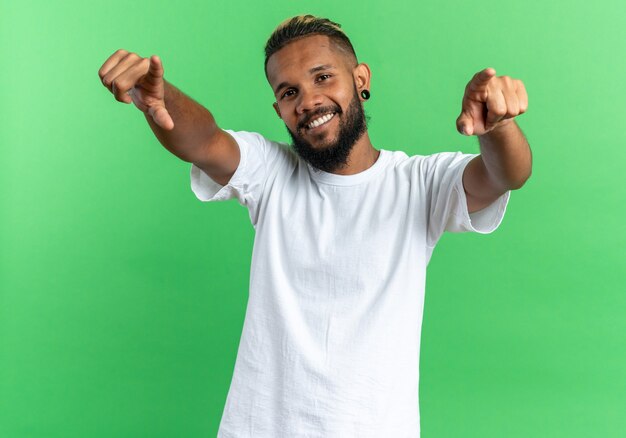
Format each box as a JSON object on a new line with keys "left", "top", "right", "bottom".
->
{"left": 191, "top": 129, "right": 280, "bottom": 225}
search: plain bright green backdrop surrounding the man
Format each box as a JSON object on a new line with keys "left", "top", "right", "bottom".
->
{"left": 0, "top": 0, "right": 626, "bottom": 438}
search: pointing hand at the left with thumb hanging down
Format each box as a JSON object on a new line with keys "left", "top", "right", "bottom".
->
{"left": 98, "top": 49, "right": 174, "bottom": 131}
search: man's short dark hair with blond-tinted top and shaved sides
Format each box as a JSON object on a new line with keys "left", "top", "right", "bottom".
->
{"left": 265, "top": 15, "right": 358, "bottom": 74}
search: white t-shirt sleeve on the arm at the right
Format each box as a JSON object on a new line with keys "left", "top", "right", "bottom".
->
{"left": 422, "top": 152, "right": 511, "bottom": 247}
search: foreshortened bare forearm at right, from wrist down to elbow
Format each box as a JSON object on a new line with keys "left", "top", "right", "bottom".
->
{"left": 478, "top": 119, "right": 532, "bottom": 190}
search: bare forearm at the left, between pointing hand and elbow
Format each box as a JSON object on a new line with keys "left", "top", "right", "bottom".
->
{"left": 145, "top": 81, "right": 219, "bottom": 162}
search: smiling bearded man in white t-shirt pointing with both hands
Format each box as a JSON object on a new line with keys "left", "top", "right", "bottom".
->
{"left": 99, "top": 15, "right": 531, "bottom": 438}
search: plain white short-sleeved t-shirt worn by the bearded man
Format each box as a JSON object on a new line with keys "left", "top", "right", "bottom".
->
{"left": 191, "top": 130, "right": 510, "bottom": 438}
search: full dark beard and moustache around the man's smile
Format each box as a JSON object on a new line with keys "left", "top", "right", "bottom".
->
{"left": 285, "top": 87, "right": 367, "bottom": 172}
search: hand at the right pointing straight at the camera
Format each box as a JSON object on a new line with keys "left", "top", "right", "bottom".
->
{"left": 456, "top": 68, "right": 528, "bottom": 135}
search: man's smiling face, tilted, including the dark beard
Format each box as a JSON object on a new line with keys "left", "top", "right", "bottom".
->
{"left": 267, "top": 35, "right": 369, "bottom": 172}
